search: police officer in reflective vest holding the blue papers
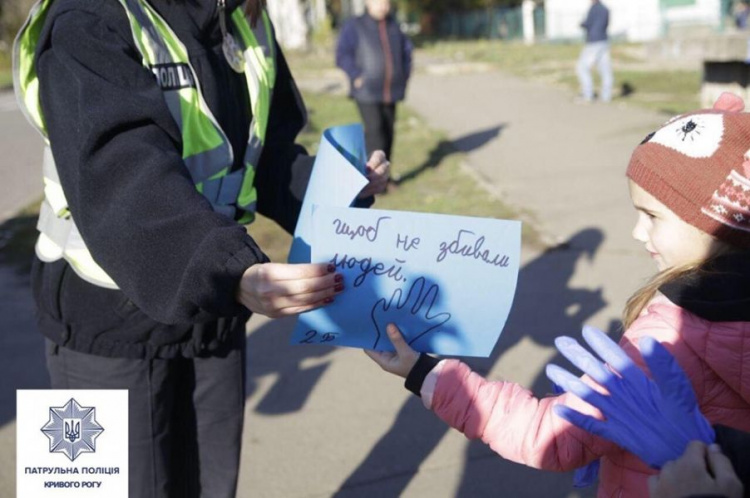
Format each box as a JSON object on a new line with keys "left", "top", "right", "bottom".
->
{"left": 14, "top": 0, "right": 388, "bottom": 498}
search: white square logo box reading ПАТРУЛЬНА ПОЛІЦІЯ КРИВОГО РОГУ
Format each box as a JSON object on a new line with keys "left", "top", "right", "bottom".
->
{"left": 16, "top": 389, "right": 128, "bottom": 498}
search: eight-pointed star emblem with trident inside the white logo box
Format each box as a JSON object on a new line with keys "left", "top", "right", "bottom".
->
{"left": 41, "top": 398, "right": 104, "bottom": 462}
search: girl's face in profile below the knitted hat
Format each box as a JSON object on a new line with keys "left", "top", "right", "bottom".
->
{"left": 628, "top": 180, "right": 719, "bottom": 271}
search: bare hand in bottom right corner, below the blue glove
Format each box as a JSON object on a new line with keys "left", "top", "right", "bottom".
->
{"left": 648, "top": 441, "right": 743, "bottom": 498}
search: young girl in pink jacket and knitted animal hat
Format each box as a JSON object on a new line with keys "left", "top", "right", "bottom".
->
{"left": 367, "top": 94, "right": 750, "bottom": 498}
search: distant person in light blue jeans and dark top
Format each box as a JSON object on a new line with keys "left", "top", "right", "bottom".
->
{"left": 576, "top": 0, "right": 614, "bottom": 102}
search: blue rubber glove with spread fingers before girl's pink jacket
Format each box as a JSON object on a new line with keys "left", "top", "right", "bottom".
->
{"left": 546, "top": 327, "right": 716, "bottom": 469}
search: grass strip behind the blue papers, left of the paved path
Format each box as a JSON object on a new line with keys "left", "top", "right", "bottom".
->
{"left": 248, "top": 89, "right": 539, "bottom": 262}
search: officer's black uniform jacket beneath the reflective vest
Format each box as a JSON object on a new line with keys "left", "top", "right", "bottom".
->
{"left": 32, "top": 0, "right": 312, "bottom": 358}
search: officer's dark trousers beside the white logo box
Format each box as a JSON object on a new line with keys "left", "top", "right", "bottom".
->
{"left": 47, "top": 337, "right": 245, "bottom": 498}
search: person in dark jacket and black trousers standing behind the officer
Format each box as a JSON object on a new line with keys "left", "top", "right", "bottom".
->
{"left": 336, "top": 0, "right": 412, "bottom": 159}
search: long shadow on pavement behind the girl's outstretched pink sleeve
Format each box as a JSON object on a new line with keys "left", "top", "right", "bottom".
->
{"left": 335, "top": 228, "right": 606, "bottom": 498}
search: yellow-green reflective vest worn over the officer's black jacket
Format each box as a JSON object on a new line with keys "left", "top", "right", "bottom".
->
{"left": 13, "top": 0, "right": 276, "bottom": 288}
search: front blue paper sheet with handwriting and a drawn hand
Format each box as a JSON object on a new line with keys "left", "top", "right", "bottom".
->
{"left": 292, "top": 206, "right": 521, "bottom": 357}
